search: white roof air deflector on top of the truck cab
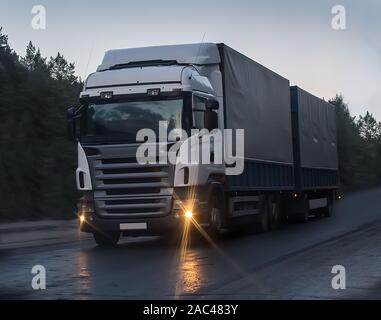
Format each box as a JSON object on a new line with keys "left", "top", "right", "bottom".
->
{"left": 97, "top": 43, "right": 221, "bottom": 71}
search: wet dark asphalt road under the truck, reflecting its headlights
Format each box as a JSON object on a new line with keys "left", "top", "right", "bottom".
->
{"left": 0, "top": 189, "right": 381, "bottom": 299}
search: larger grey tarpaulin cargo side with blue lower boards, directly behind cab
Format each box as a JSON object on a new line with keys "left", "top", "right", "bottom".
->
{"left": 218, "top": 44, "right": 294, "bottom": 191}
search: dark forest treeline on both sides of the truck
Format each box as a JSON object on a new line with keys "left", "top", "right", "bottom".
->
{"left": 0, "top": 29, "right": 381, "bottom": 221}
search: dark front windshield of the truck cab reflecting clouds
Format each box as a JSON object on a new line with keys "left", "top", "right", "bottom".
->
{"left": 81, "top": 97, "right": 187, "bottom": 142}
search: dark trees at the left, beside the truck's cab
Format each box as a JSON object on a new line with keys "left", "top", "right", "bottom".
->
{"left": 0, "top": 31, "right": 82, "bottom": 220}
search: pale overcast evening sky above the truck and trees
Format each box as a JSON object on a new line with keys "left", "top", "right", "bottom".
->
{"left": 0, "top": 0, "right": 381, "bottom": 120}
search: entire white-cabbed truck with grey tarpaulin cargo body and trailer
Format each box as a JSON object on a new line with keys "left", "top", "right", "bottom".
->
{"left": 67, "top": 43, "right": 339, "bottom": 246}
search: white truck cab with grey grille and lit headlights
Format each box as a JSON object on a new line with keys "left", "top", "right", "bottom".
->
{"left": 69, "top": 43, "right": 224, "bottom": 244}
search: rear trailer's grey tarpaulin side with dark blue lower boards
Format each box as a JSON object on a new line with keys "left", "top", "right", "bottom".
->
{"left": 291, "top": 86, "right": 338, "bottom": 189}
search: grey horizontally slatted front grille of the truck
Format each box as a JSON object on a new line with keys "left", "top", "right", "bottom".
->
{"left": 91, "top": 157, "right": 172, "bottom": 218}
